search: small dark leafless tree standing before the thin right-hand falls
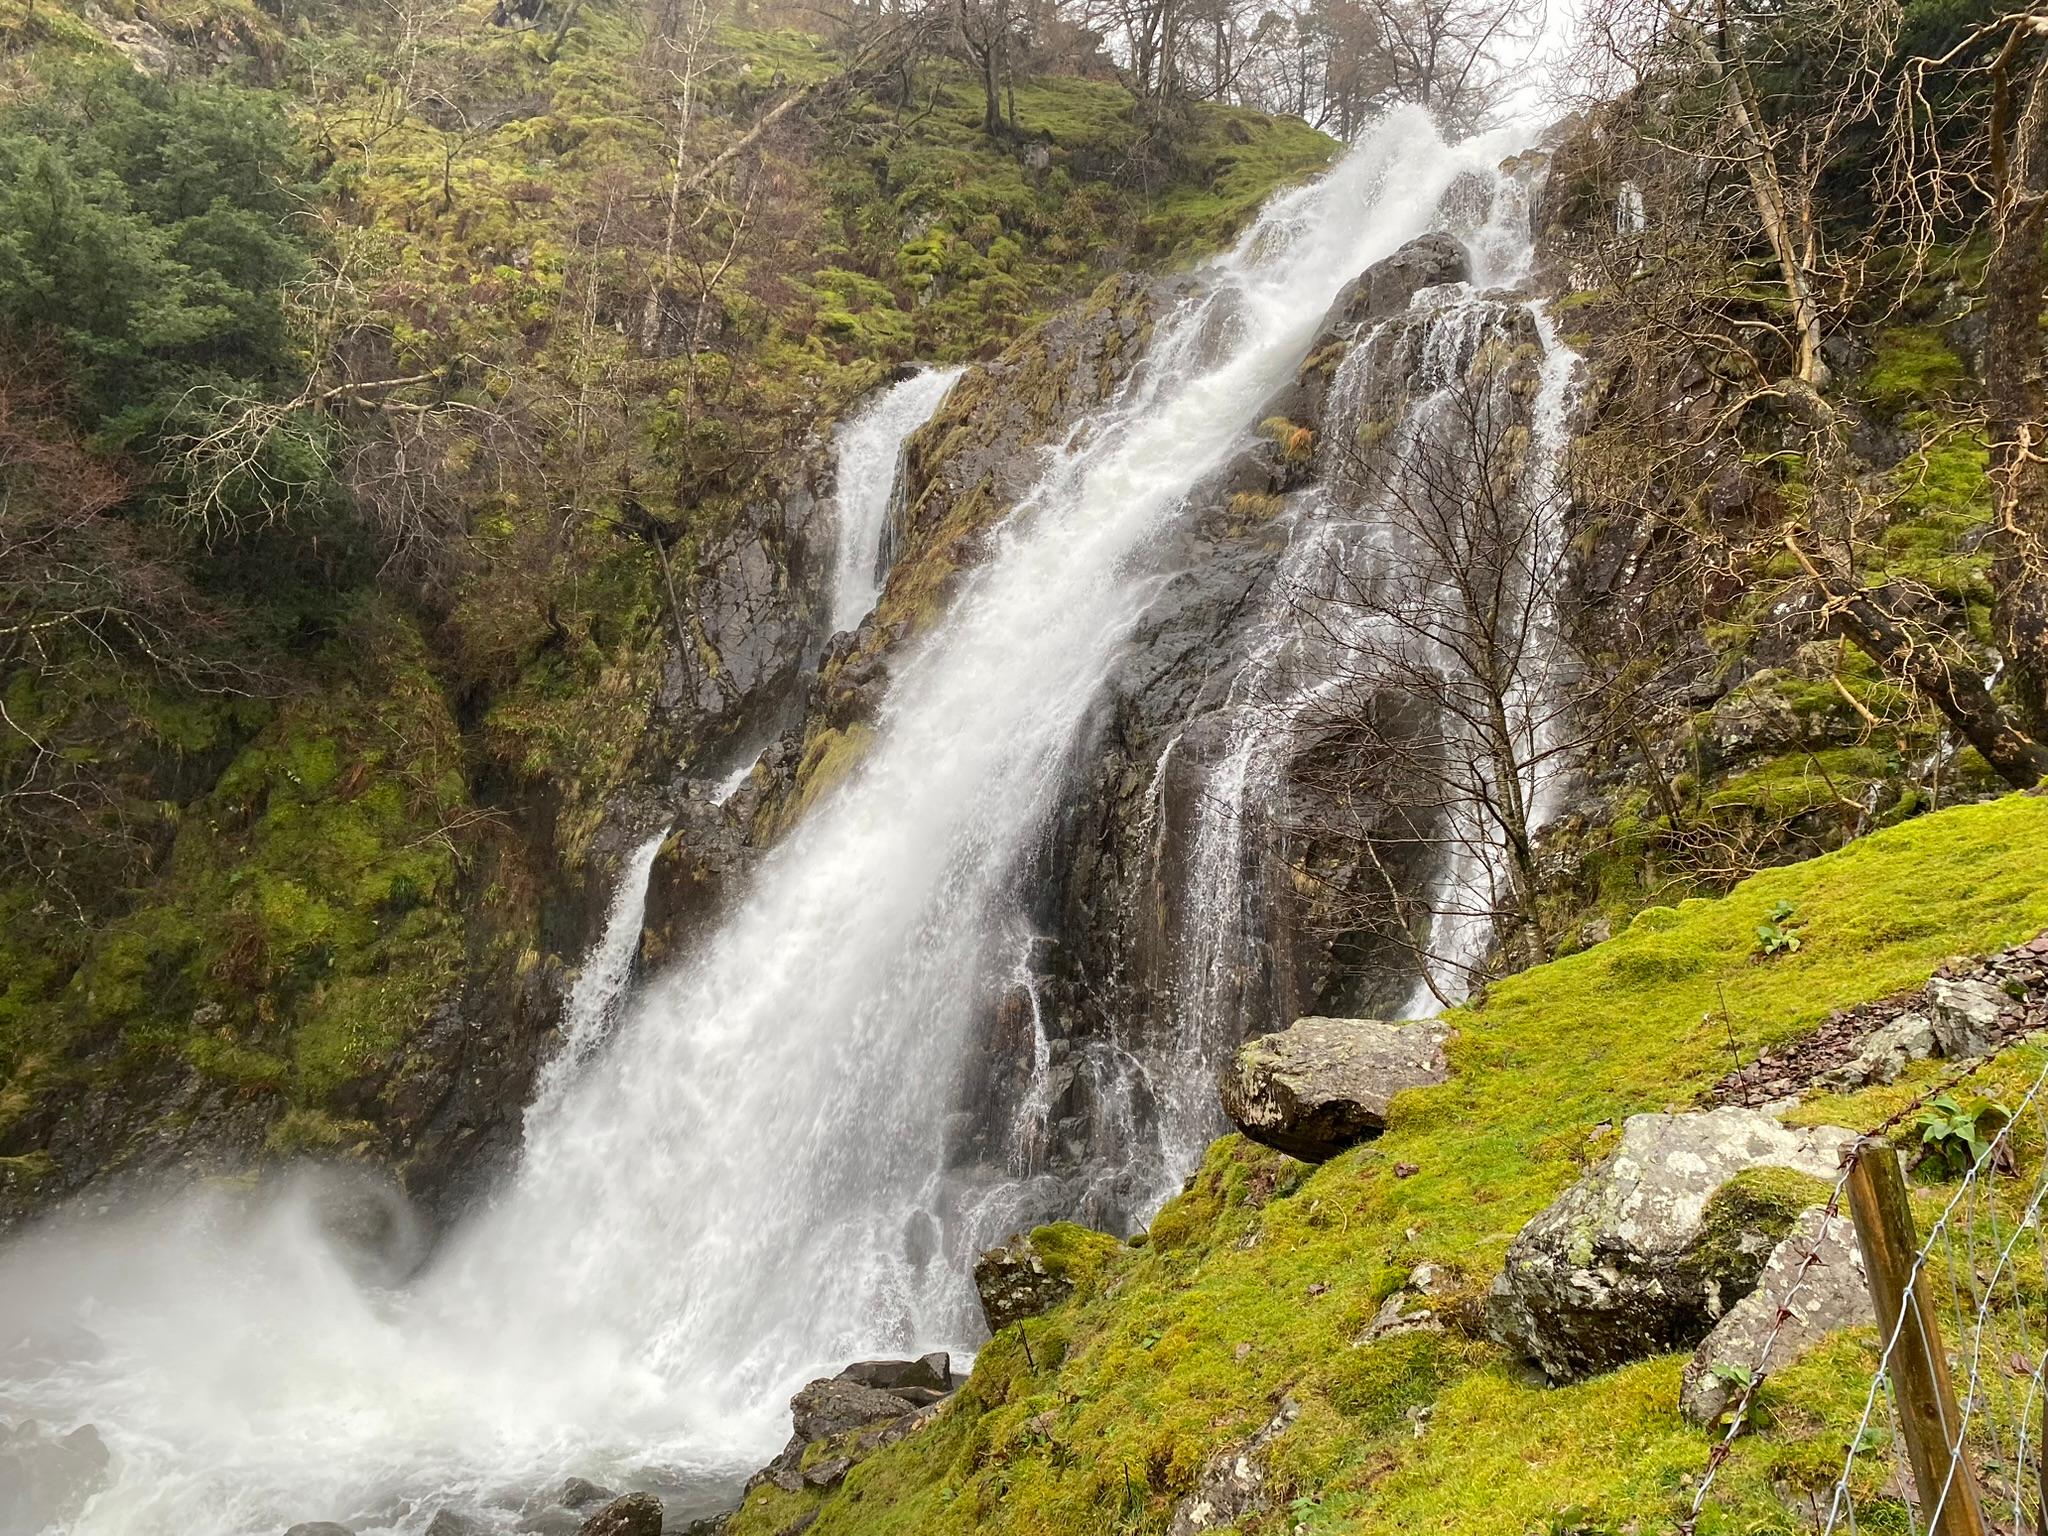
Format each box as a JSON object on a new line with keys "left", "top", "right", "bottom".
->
{"left": 1276, "top": 342, "right": 1589, "bottom": 999}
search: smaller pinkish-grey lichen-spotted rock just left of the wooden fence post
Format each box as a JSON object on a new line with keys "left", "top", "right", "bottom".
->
{"left": 1677, "top": 1206, "right": 1870, "bottom": 1425}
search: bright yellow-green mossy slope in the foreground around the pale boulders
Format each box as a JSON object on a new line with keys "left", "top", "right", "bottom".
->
{"left": 733, "top": 797, "right": 2048, "bottom": 1536}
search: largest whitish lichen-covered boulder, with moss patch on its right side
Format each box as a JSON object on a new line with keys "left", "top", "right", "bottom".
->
{"left": 1487, "top": 1108, "right": 1855, "bottom": 1380}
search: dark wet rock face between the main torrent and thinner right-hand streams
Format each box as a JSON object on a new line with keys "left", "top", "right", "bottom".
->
{"left": 983, "top": 236, "right": 1536, "bottom": 1227}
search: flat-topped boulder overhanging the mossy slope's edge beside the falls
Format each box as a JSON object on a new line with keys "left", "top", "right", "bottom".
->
{"left": 1223, "top": 1018, "right": 1448, "bottom": 1163}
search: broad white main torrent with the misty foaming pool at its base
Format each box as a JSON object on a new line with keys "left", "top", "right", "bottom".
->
{"left": 0, "top": 113, "right": 1564, "bottom": 1536}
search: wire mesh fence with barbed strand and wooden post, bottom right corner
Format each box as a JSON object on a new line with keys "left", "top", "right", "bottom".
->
{"left": 1679, "top": 1040, "right": 2048, "bottom": 1536}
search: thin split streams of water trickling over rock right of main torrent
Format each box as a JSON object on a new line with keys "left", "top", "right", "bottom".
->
{"left": 1089, "top": 159, "right": 1577, "bottom": 1204}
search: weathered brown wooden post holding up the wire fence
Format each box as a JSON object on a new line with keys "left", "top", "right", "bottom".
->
{"left": 1849, "top": 1139, "right": 1985, "bottom": 1536}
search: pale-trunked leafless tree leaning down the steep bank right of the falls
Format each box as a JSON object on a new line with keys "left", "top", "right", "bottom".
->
{"left": 1548, "top": 0, "right": 2048, "bottom": 784}
